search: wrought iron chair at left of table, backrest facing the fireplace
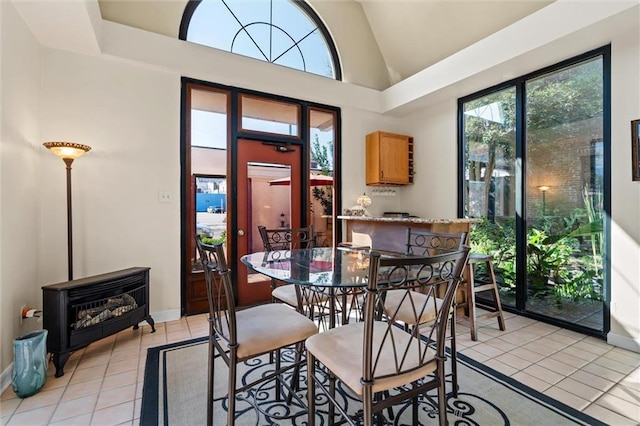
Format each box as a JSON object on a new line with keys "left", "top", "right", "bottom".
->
{"left": 196, "top": 236, "right": 318, "bottom": 426}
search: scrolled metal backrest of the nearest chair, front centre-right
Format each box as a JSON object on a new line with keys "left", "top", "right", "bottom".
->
{"left": 362, "top": 246, "right": 469, "bottom": 382}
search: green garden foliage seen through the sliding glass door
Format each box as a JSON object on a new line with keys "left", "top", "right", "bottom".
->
{"left": 464, "top": 58, "right": 604, "bottom": 305}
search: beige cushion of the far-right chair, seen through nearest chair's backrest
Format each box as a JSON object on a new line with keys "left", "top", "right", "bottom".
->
{"left": 384, "top": 290, "right": 443, "bottom": 325}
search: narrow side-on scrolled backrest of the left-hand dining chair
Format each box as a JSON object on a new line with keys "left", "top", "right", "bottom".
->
{"left": 196, "top": 235, "right": 237, "bottom": 345}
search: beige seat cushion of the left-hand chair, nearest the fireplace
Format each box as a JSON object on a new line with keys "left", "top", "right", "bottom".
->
{"left": 236, "top": 303, "right": 318, "bottom": 359}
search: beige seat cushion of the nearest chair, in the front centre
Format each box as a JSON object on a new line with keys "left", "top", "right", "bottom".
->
{"left": 306, "top": 321, "right": 436, "bottom": 396}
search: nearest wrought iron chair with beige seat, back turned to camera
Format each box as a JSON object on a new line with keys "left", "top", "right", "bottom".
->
{"left": 306, "top": 246, "right": 469, "bottom": 426}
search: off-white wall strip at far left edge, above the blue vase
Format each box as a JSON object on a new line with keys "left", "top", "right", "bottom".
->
{"left": 0, "top": 2, "right": 43, "bottom": 381}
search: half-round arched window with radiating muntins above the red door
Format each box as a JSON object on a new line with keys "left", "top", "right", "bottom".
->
{"left": 180, "top": 0, "right": 342, "bottom": 80}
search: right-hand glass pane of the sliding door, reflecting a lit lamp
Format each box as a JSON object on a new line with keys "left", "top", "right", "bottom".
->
{"left": 525, "top": 57, "right": 604, "bottom": 330}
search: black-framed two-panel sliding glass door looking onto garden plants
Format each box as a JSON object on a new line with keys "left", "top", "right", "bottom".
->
{"left": 459, "top": 47, "right": 610, "bottom": 334}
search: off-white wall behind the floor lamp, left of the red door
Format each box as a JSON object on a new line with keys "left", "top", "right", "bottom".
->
{"left": 40, "top": 49, "right": 180, "bottom": 322}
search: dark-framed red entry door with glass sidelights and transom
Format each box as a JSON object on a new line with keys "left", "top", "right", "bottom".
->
{"left": 180, "top": 78, "right": 341, "bottom": 315}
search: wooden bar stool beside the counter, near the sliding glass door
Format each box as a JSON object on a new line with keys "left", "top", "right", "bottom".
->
{"left": 463, "top": 253, "right": 506, "bottom": 341}
